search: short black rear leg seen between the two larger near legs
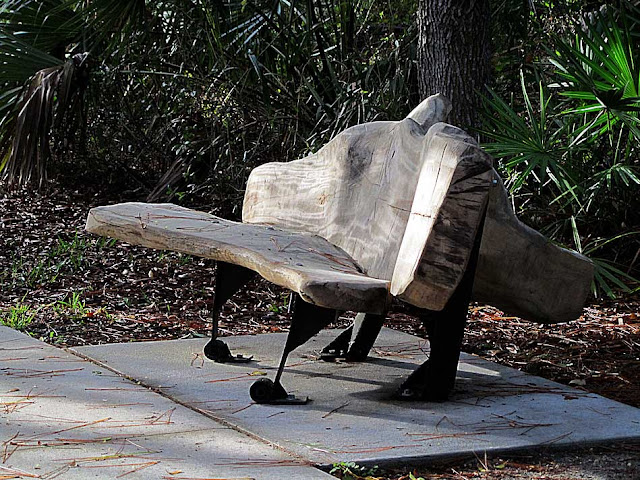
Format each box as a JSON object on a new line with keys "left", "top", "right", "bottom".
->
{"left": 320, "top": 313, "right": 385, "bottom": 362}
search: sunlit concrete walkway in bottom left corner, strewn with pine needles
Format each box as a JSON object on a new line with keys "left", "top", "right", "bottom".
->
{"left": 0, "top": 326, "right": 333, "bottom": 480}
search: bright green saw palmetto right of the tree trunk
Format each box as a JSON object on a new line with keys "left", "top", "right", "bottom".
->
{"left": 484, "top": 9, "right": 640, "bottom": 296}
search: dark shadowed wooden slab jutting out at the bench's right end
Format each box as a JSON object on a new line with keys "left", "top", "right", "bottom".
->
{"left": 473, "top": 175, "right": 593, "bottom": 323}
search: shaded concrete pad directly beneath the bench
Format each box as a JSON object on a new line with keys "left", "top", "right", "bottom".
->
{"left": 77, "top": 329, "right": 640, "bottom": 465}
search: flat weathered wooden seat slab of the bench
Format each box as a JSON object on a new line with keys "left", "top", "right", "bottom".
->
{"left": 86, "top": 203, "right": 389, "bottom": 313}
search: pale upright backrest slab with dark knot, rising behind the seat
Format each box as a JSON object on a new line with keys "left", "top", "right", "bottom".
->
{"left": 242, "top": 95, "right": 450, "bottom": 280}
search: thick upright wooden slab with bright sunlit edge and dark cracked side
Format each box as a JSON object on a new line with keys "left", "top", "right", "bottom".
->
{"left": 391, "top": 123, "right": 494, "bottom": 310}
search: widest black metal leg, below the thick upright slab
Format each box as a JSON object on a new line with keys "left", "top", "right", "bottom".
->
{"left": 396, "top": 210, "right": 484, "bottom": 402}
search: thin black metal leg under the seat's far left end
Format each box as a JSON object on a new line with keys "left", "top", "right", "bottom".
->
{"left": 204, "top": 262, "right": 255, "bottom": 363}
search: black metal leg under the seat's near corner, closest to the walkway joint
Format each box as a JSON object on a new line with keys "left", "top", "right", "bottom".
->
{"left": 249, "top": 294, "right": 338, "bottom": 404}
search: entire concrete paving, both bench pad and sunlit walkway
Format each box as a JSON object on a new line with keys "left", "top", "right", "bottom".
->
{"left": 0, "top": 327, "right": 640, "bottom": 480}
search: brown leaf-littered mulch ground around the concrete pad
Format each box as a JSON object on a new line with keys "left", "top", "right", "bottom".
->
{"left": 0, "top": 185, "right": 640, "bottom": 479}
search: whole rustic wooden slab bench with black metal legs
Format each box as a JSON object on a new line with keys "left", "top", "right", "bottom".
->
{"left": 86, "top": 95, "right": 593, "bottom": 403}
